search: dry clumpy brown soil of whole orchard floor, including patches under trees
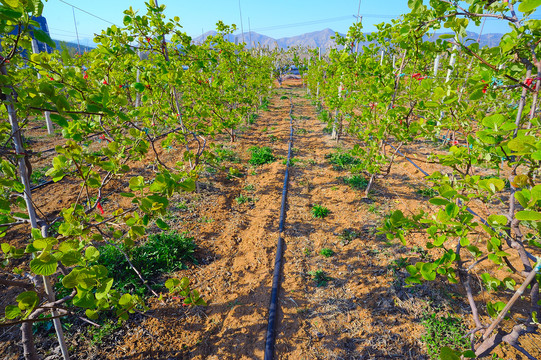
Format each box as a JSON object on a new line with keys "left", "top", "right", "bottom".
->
{"left": 0, "top": 79, "right": 539, "bottom": 360}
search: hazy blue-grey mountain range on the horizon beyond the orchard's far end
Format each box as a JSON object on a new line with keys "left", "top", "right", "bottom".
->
{"left": 193, "top": 28, "right": 502, "bottom": 50}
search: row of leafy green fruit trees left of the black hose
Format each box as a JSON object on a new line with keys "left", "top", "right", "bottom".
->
{"left": 0, "top": 0, "right": 272, "bottom": 359}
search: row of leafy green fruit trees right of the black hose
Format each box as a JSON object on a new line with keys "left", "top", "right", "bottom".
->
{"left": 306, "top": 0, "right": 541, "bottom": 359}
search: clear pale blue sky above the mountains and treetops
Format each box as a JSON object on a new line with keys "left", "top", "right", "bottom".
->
{"left": 43, "top": 0, "right": 540, "bottom": 45}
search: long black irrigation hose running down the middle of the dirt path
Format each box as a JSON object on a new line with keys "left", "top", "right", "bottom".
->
{"left": 264, "top": 98, "right": 293, "bottom": 360}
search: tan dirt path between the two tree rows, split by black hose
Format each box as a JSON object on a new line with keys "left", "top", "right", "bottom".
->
{"left": 97, "top": 83, "right": 436, "bottom": 359}
